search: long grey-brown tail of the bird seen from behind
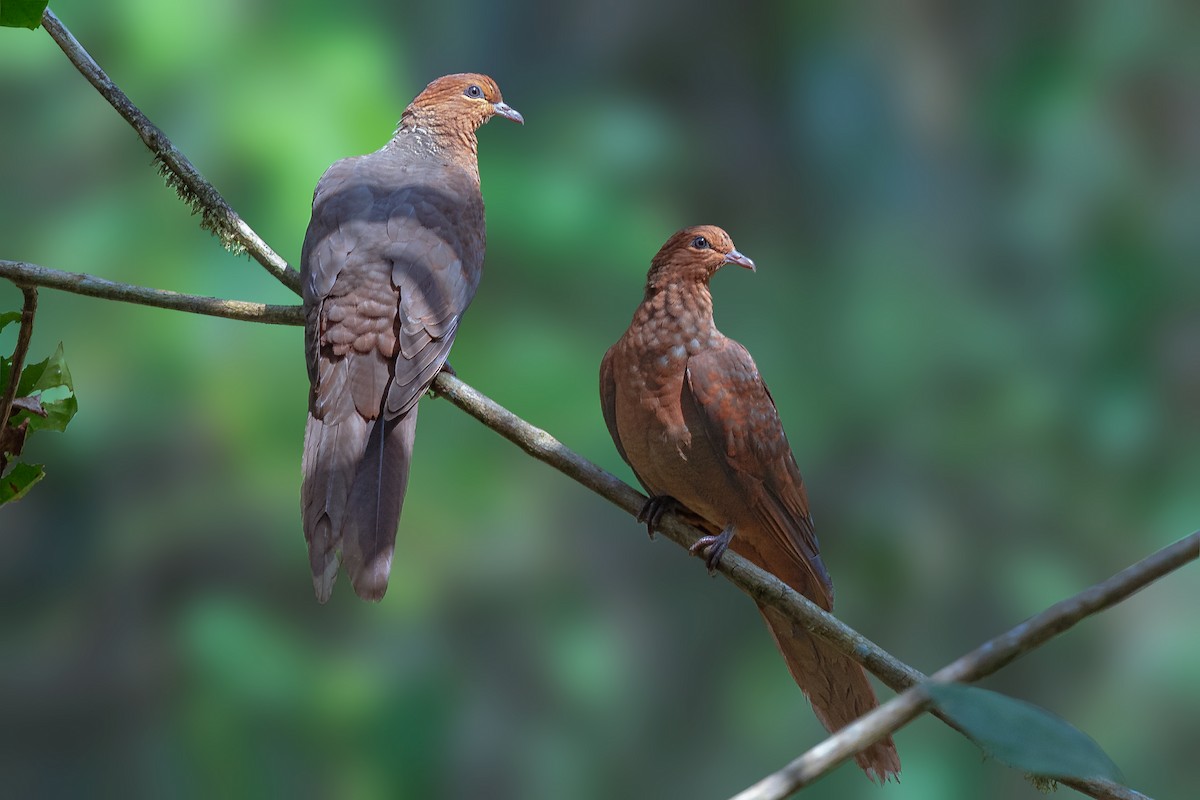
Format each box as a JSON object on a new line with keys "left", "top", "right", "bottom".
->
{"left": 300, "top": 405, "right": 416, "bottom": 602}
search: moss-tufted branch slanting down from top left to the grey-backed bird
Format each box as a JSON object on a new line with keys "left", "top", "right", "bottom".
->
{"left": 42, "top": 8, "right": 300, "bottom": 294}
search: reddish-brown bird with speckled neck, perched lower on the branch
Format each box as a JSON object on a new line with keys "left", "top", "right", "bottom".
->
{"left": 600, "top": 225, "right": 900, "bottom": 783}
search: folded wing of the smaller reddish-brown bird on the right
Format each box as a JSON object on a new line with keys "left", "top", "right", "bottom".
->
{"left": 682, "top": 339, "right": 833, "bottom": 604}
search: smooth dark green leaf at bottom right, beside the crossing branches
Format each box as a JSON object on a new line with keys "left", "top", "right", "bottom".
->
{"left": 925, "top": 681, "right": 1123, "bottom": 783}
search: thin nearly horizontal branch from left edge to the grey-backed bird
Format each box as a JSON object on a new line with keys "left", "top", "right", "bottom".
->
{"left": 0, "top": 259, "right": 304, "bottom": 325}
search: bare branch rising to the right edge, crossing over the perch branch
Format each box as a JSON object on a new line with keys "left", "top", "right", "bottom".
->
{"left": 733, "top": 531, "right": 1200, "bottom": 800}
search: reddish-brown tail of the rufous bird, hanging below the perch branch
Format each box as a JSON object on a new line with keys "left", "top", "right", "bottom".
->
{"left": 758, "top": 604, "right": 900, "bottom": 783}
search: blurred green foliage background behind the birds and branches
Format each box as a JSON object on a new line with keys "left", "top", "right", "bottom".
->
{"left": 0, "top": 0, "right": 1200, "bottom": 800}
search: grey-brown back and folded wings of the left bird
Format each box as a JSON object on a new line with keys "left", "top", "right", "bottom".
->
{"left": 301, "top": 152, "right": 485, "bottom": 419}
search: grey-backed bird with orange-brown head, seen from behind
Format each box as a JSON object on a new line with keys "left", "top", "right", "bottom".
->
{"left": 300, "top": 73, "right": 524, "bottom": 602}
